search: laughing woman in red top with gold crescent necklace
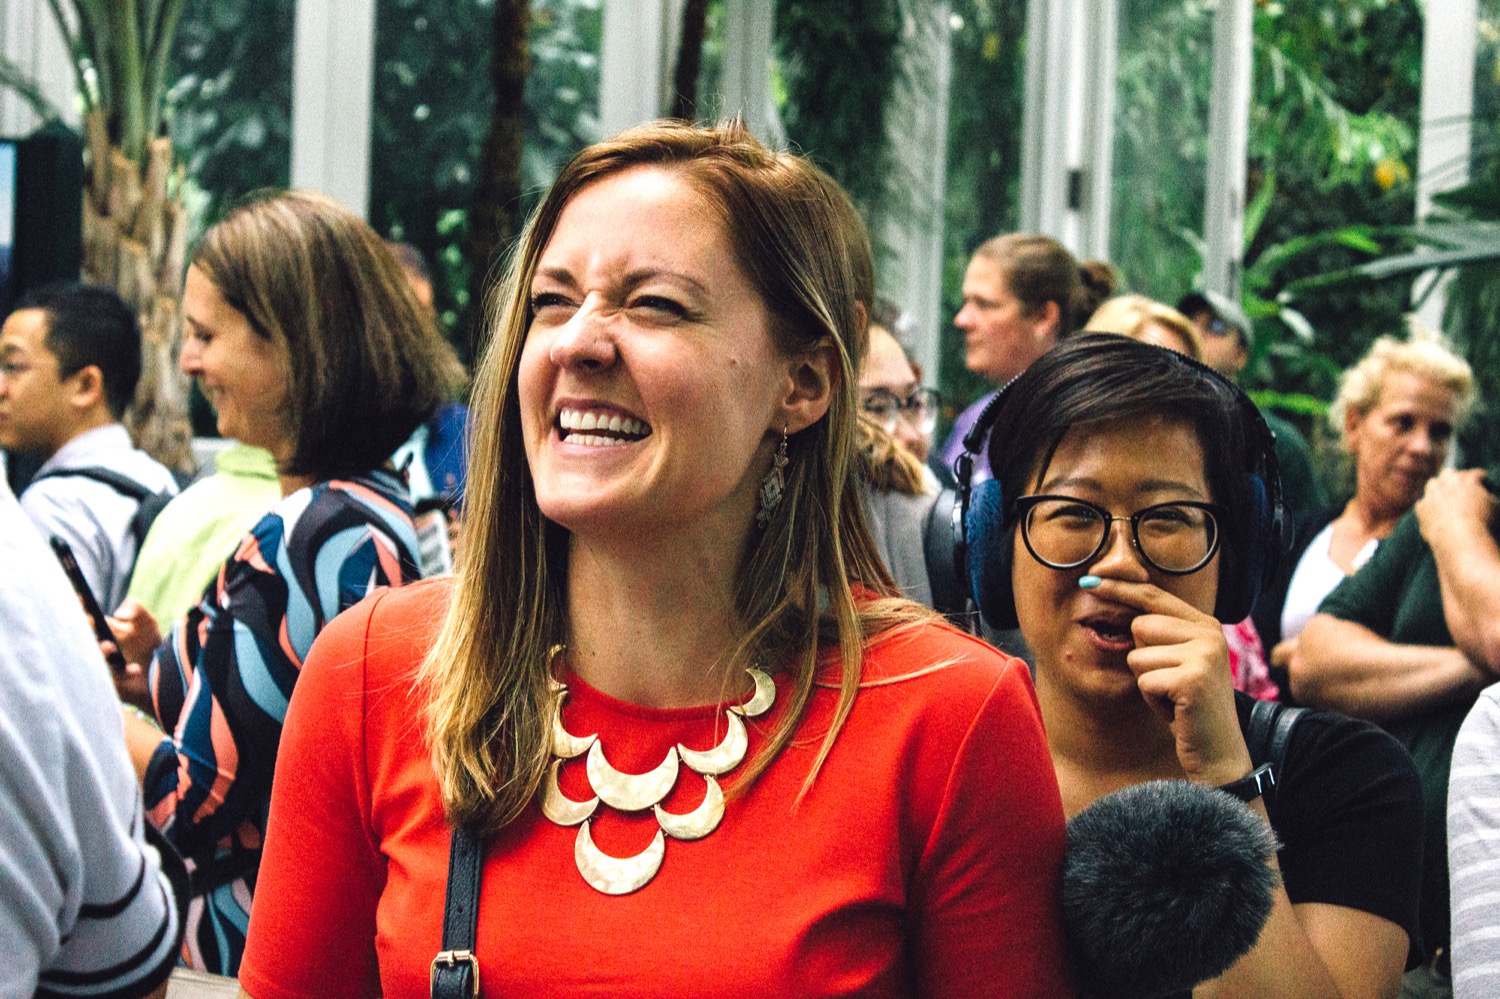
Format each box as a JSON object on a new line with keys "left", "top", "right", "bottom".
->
{"left": 240, "top": 123, "right": 1070, "bottom": 998}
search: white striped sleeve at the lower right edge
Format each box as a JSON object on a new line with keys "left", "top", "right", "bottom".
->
{"left": 1448, "top": 684, "right": 1500, "bottom": 999}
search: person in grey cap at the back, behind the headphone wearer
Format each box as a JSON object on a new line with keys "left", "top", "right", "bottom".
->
{"left": 1178, "top": 288, "right": 1328, "bottom": 525}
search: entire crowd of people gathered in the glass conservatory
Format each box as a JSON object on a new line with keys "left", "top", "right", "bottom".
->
{"left": 0, "top": 123, "right": 1500, "bottom": 999}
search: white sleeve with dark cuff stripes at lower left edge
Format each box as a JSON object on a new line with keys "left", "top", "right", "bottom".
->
{"left": 0, "top": 480, "right": 182, "bottom": 999}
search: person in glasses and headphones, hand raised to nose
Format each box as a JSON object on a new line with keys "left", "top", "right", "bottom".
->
{"left": 968, "top": 335, "right": 1422, "bottom": 996}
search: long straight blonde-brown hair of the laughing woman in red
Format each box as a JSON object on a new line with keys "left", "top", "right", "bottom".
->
{"left": 420, "top": 122, "right": 929, "bottom": 831}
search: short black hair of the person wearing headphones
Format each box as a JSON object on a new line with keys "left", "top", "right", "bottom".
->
{"left": 989, "top": 333, "right": 1263, "bottom": 579}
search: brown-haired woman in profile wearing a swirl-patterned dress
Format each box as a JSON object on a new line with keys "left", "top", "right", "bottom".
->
{"left": 116, "top": 192, "right": 459, "bottom": 975}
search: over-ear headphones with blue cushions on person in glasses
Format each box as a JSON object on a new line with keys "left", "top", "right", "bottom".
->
{"left": 953, "top": 345, "right": 1284, "bottom": 630}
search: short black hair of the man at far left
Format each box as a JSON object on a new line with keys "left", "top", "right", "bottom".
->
{"left": 15, "top": 281, "right": 141, "bottom": 420}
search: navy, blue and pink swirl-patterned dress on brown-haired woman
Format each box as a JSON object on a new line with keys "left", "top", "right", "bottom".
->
{"left": 144, "top": 471, "right": 420, "bottom": 975}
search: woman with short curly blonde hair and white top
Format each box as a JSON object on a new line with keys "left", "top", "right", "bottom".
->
{"left": 1257, "top": 329, "right": 1475, "bottom": 654}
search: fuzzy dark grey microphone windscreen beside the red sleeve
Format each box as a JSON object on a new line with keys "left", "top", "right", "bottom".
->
{"left": 1062, "top": 780, "right": 1280, "bottom": 999}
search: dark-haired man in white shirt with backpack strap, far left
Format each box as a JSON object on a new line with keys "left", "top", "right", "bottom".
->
{"left": 0, "top": 277, "right": 177, "bottom": 611}
